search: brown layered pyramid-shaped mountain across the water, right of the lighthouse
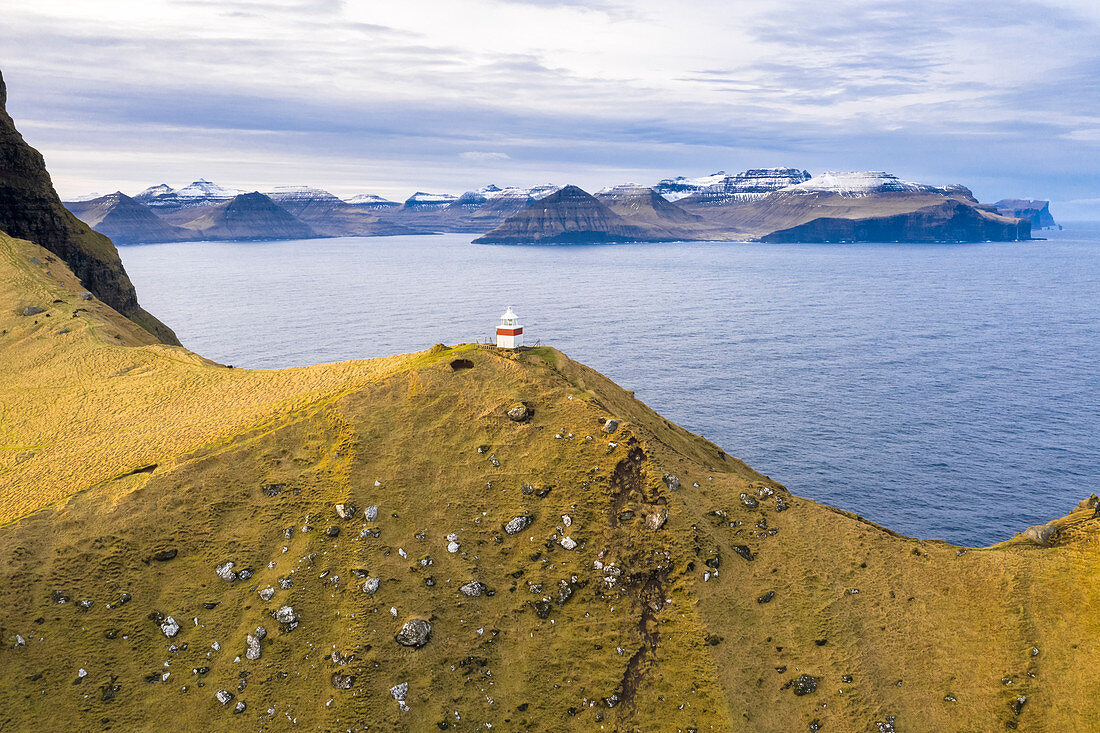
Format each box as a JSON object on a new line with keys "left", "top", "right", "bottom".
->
{"left": 474, "top": 186, "right": 651, "bottom": 244}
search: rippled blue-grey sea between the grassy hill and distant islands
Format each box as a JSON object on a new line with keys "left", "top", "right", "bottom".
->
{"left": 121, "top": 223, "right": 1100, "bottom": 546}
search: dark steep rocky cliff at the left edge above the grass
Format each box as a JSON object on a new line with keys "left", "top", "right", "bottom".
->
{"left": 0, "top": 68, "right": 179, "bottom": 344}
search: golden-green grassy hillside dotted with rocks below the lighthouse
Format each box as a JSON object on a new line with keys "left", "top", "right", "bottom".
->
{"left": 0, "top": 230, "right": 1100, "bottom": 732}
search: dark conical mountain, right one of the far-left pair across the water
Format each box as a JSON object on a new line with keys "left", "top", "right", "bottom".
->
{"left": 177, "top": 193, "right": 317, "bottom": 240}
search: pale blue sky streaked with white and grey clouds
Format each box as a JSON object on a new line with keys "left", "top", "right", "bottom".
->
{"left": 0, "top": 0, "right": 1100, "bottom": 220}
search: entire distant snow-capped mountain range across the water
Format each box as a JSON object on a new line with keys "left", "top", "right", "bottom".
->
{"left": 66, "top": 167, "right": 1056, "bottom": 244}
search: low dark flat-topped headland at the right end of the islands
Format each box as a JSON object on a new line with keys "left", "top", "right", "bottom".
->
{"left": 760, "top": 199, "right": 1031, "bottom": 242}
